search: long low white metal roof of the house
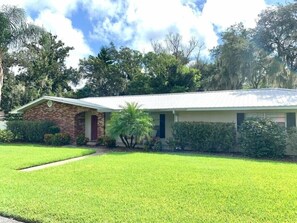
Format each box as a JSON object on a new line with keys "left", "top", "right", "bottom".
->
{"left": 13, "top": 88, "right": 297, "bottom": 112}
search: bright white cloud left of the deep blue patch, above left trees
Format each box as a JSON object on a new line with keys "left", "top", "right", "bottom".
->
{"left": 34, "top": 10, "right": 92, "bottom": 67}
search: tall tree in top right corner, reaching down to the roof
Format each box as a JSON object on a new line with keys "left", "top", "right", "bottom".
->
{"left": 254, "top": 1, "right": 297, "bottom": 88}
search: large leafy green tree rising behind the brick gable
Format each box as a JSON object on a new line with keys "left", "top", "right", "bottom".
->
{"left": 14, "top": 32, "right": 79, "bottom": 103}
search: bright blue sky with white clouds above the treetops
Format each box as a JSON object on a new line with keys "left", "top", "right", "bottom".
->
{"left": 0, "top": 0, "right": 293, "bottom": 67}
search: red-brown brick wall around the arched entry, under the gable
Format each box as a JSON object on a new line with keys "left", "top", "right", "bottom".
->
{"left": 23, "top": 102, "right": 104, "bottom": 142}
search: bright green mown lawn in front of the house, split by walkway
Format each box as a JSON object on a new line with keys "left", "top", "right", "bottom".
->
{"left": 0, "top": 145, "right": 297, "bottom": 223}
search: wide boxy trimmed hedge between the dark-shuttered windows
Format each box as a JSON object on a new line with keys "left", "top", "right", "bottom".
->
{"left": 172, "top": 122, "right": 236, "bottom": 152}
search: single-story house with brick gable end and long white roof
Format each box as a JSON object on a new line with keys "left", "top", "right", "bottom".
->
{"left": 12, "top": 88, "right": 297, "bottom": 152}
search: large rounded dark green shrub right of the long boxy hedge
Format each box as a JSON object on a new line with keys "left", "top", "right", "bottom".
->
{"left": 239, "top": 118, "right": 286, "bottom": 158}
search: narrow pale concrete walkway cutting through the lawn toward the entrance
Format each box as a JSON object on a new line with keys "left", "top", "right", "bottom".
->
{"left": 19, "top": 149, "right": 107, "bottom": 172}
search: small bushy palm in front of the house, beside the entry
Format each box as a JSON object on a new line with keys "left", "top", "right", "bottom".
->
{"left": 107, "top": 103, "right": 153, "bottom": 149}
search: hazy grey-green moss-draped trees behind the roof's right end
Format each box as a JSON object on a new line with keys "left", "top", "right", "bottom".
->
{"left": 197, "top": 2, "right": 297, "bottom": 90}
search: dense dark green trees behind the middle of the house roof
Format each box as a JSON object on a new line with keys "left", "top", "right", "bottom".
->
{"left": 76, "top": 44, "right": 201, "bottom": 98}
